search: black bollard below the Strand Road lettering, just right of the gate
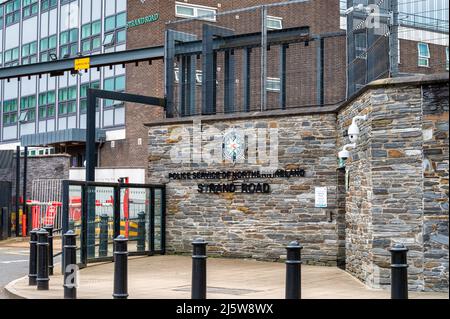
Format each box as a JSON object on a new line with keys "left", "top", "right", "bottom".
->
{"left": 191, "top": 238, "right": 208, "bottom": 299}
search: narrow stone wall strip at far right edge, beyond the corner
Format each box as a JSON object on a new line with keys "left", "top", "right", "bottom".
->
{"left": 422, "top": 83, "right": 449, "bottom": 290}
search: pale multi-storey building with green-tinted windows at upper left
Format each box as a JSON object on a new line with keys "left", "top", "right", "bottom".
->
{"left": 0, "top": 0, "right": 127, "bottom": 166}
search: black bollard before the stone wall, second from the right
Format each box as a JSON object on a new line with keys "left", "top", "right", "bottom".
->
{"left": 286, "top": 241, "right": 303, "bottom": 299}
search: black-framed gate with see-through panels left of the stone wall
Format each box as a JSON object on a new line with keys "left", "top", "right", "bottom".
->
{"left": 62, "top": 181, "right": 166, "bottom": 268}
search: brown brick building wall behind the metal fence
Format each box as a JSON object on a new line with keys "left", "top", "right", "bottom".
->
{"left": 105, "top": 0, "right": 345, "bottom": 174}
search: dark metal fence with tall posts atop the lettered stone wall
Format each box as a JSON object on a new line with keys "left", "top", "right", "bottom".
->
{"left": 165, "top": 1, "right": 346, "bottom": 117}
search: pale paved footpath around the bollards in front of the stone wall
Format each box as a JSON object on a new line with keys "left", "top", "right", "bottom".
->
{"left": 6, "top": 256, "right": 448, "bottom": 299}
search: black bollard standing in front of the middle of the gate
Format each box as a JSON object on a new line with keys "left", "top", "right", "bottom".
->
{"left": 113, "top": 235, "right": 128, "bottom": 299}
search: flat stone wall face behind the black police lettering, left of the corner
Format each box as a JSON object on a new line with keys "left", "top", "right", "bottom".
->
{"left": 148, "top": 114, "right": 338, "bottom": 265}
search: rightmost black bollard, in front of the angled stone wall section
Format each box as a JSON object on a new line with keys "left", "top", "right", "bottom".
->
{"left": 390, "top": 244, "right": 408, "bottom": 299}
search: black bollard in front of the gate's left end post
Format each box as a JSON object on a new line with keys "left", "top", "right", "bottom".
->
{"left": 63, "top": 230, "right": 78, "bottom": 299}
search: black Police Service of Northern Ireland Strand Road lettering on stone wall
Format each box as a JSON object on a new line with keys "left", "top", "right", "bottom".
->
{"left": 169, "top": 169, "right": 305, "bottom": 194}
